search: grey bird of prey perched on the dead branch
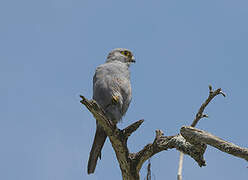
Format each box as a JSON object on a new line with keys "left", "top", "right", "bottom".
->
{"left": 87, "top": 48, "right": 136, "bottom": 174}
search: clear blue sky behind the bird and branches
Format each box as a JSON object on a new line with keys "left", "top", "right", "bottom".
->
{"left": 0, "top": 0, "right": 248, "bottom": 180}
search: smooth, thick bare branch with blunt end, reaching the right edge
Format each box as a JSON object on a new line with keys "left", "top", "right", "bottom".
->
{"left": 180, "top": 126, "right": 248, "bottom": 161}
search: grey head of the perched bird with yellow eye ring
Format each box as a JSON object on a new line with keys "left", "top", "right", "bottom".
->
{"left": 106, "top": 48, "right": 135, "bottom": 66}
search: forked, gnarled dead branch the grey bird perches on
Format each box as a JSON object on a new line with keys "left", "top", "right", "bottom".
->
{"left": 80, "top": 96, "right": 206, "bottom": 180}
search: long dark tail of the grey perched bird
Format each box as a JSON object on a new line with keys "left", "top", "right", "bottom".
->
{"left": 88, "top": 126, "right": 107, "bottom": 174}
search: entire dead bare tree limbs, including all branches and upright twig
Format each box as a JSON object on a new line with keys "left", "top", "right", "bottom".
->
{"left": 80, "top": 86, "right": 248, "bottom": 180}
